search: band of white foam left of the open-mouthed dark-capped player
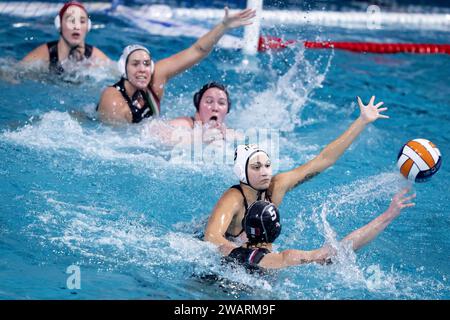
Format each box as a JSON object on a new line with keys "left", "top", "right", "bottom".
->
{"left": 0, "top": 110, "right": 243, "bottom": 176}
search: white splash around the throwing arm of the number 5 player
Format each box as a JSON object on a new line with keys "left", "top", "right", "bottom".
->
{"left": 282, "top": 173, "right": 418, "bottom": 297}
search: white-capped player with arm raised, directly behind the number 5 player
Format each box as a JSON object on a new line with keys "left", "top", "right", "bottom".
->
{"left": 204, "top": 97, "right": 388, "bottom": 251}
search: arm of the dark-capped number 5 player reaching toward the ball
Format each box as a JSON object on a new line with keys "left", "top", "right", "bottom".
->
{"left": 259, "top": 189, "right": 416, "bottom": 269}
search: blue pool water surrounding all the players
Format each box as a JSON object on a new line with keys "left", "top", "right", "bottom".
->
{"left": 0, "top": 4, "right": 450, "bottom": 299}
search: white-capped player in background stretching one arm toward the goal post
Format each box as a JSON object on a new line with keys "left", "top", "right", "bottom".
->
{"left": 98, "top": 8, "right": 255, "bottom": 123}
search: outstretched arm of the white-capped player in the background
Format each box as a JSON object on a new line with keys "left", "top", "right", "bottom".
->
{"left": 153, "top": 7, "right": 255, "bottom": 93}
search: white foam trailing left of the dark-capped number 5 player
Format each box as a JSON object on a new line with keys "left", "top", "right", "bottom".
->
{"left": 28, "top": 191, "right": 278, "bottom": 290}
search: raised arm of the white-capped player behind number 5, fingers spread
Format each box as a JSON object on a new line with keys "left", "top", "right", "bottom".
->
{"left": 274, "top": 96, "right": 389, "bottom": 199}
